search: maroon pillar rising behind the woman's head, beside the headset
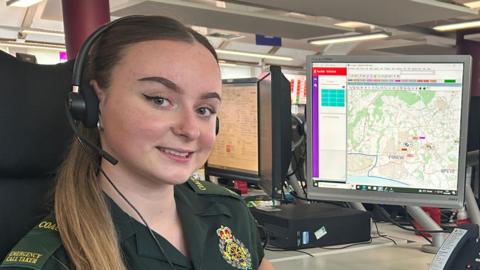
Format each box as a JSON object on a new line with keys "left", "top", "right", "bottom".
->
{"left": 62, "top": 0, "right": 110, "bottom": 59}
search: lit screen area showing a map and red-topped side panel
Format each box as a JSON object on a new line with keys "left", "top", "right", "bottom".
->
{"left": 312, "top": 63, "right": 463, "bottom": 195}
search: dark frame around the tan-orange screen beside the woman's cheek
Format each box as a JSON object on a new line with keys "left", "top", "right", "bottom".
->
{"left": 204, "top": 78, "right": 260, "bottom": 184}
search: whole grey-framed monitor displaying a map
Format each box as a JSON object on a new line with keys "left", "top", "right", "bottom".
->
{"left": 307, "top": 55, "right": 471, "bottom": 207}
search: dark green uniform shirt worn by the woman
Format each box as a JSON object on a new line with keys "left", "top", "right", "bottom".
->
{"left": 0, "top": 180, "right": 264, "bottom": 270}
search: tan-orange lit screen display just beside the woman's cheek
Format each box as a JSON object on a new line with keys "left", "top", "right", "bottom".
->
{"left": 208, "top": 83, "right": 258, "bottom": 175}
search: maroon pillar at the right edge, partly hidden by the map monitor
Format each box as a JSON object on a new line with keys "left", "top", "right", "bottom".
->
{"left": 457, "top": 29, "right": 480, "bottom": 96}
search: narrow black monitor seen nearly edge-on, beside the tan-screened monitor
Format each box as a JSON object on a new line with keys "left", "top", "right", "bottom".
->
{"left": 258, "top": 66, "right": 292, "bottom": 199}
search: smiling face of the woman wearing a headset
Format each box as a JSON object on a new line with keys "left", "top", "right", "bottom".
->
{"left": 97, "top": 40, "right": 221, "bottom": 184}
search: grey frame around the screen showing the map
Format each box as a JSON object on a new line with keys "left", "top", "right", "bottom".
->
{"left": 306, "top": 55, "right": 472, "bottom": 208}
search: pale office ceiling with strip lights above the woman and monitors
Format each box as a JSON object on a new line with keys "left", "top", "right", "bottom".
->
{"left": 0, "top": 0, "right": 480, "bottom": 69}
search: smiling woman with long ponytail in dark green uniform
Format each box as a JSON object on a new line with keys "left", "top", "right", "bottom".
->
{"left": 0, "top": 16, "right": 273, "bottom": 270}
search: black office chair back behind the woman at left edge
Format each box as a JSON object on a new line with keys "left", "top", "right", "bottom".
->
{"left": 0, "top": 51, "right": 73, "bottom": 261}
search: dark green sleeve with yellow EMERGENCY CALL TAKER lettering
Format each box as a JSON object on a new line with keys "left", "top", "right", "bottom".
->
{"left": 0, "top": 218, "right": 62, "bottom": 270}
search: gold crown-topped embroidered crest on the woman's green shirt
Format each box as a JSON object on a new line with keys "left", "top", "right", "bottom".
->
{"left": 217, "top": 225, "right": 252, "bottom": 270}
